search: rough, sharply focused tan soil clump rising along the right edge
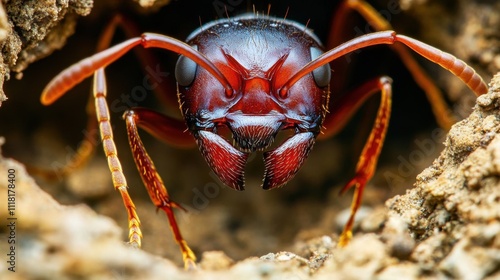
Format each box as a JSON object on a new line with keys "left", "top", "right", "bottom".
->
{"left": 386, "top": 71, "right": 500, "bottom": 279}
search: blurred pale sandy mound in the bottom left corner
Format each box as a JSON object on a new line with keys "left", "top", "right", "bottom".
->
{"left": 0, "top": 148, "right": 188, "bottom": 279}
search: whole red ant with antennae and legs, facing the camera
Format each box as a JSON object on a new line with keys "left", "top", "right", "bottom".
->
{"left": 41, "top": 1, "right": 487, "bottom": 267}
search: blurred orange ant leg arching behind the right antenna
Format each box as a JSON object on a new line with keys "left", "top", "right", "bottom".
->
{"left": 330, "top": 0, "right": 457, "bottom": 130}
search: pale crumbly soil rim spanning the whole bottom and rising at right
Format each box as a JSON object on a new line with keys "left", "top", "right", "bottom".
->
{"left": 0, "top": 73, "right": 500, "bottom": 279}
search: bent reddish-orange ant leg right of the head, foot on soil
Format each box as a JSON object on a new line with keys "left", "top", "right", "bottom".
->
{"left": 331, "top": 77, "right": 392, "bottom": 247}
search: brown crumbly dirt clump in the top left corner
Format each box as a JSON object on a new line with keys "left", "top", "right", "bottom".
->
{"left": 0, "top": 0, "right": 93, "bottom": 106}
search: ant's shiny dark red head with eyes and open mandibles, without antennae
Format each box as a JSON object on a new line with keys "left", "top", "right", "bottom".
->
{"left": 175, "top": 14, "right": 331, "bottom": 190}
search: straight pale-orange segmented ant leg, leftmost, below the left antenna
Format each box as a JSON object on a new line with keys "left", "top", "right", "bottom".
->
{"left": 93, "top": 68, "right": 142, "bottom": 247}
